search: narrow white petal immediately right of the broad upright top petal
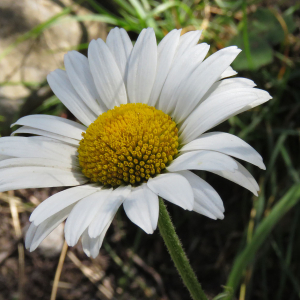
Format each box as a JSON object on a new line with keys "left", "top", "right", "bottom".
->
{"left": 148, "top": 29, "right": 181, "bottom": 106}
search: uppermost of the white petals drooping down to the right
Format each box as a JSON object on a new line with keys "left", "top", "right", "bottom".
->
{"left": 180, "top": 132, "right": 266, "bottom": 170}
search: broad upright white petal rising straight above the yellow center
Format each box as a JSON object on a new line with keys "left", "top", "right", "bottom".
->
{"left": 127, "top": 28, "right": 157, "bottom": 104}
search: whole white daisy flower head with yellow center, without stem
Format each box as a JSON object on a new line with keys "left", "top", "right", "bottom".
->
{"left": 0, "top": 28, "right": 271, "bottom": 257}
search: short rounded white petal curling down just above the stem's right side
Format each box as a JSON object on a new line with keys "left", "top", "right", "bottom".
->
{"left": 147, "top": 173, "right": 194, "bottom": 210}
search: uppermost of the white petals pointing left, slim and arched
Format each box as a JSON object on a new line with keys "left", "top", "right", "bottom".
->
{"left": 10, "top": 115, "right": 86, "bottom": 141}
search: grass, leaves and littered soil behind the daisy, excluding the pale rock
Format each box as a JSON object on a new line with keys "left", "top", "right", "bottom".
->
{"left": 0, "top": 0, "right": 300, "bottom": 300}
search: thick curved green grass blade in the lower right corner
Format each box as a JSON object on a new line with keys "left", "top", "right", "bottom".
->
{"left": 226, "top": 184, "right": 300, "bottom": 300}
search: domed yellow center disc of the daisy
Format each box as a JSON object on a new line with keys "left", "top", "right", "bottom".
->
{"left": 78, "top": 103, "right": 178, "bottom": 187}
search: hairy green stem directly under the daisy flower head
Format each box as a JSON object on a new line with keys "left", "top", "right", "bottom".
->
{"left": 158, "top": 198, "right": 207, "bottom": 300}
